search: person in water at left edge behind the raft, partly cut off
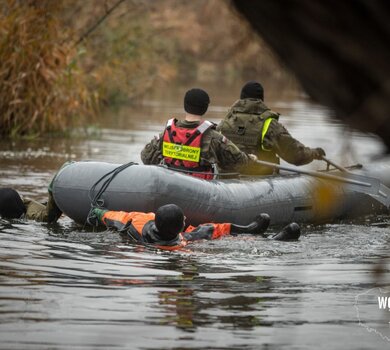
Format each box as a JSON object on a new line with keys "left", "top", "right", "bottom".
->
{"left": 0, "top": 186, "right": 62, "bottom": 223}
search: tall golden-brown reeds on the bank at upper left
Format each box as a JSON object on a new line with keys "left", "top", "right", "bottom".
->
{"left": 0, "top": 0, "right": 92, "bottom": 137}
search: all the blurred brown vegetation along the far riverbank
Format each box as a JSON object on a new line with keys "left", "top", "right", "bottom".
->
{"left": 0, "top": 0, "right": 294, "bottom": 138}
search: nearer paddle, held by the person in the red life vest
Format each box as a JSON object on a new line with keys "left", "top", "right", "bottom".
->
{"left": 256, "top": 160, "right": 390, "bottom": 208}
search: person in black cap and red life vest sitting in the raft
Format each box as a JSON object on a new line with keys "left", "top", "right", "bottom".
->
{"left": 141, "top": 89, "right": 256, "bottom": 180}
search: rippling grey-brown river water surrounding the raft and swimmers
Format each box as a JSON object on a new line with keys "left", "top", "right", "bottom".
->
{"left": 0, "top": 83, "right": 390, "bottom": 349}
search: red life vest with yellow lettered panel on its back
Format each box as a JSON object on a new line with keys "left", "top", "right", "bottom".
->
{"left": 162, "top": 119, "right": 213, "bottom": 180}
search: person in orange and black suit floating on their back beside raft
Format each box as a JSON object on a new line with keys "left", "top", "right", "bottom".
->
{"left": 87, "top": 204, "right": 300, "bottom": 250}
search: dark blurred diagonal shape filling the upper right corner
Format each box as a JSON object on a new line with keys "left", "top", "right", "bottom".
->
{"left": 233, "top": 0, "right": 390, "bottom": 153}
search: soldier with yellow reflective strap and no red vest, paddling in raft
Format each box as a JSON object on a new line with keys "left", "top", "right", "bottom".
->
{"left": 217, "top": 81, "right": 325, "bottom": 175}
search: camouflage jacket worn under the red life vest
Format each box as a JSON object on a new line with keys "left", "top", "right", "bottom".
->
{"left": 141, "top": 120, "right": 251, "bottom": 171}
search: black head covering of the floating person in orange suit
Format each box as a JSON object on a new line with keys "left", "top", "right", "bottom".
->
{"left": 154, "top": 204, "right": 184, "bottom": 240}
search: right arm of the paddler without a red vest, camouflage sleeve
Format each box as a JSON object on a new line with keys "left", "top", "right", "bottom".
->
{"left": 263, "top": 120, "right": 325, "bottom": 165}
